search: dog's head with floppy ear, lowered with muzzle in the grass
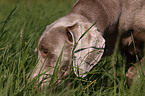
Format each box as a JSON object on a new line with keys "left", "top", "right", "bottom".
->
{"left": 33, "top": 15, "right": 105, "bottom": 83}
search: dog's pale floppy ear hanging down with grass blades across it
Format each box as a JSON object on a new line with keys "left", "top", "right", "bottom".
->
{"left": 67, "top": 22, "right": 105, "bottom": 77}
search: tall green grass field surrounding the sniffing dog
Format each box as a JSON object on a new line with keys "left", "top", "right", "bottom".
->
{"left": 0, "top": 0, "right": 145, "bottom": 96}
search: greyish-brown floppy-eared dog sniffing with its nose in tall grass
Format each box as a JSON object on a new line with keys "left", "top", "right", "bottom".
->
{"left": 32, "top": 0, "right": 145, "bottom": 85}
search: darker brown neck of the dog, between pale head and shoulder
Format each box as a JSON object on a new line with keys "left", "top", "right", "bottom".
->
{"left": 69, "top": 0, "right": 121, "bottom": 32}
